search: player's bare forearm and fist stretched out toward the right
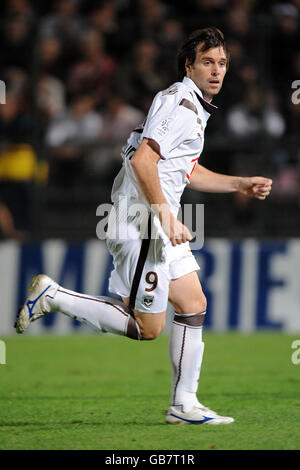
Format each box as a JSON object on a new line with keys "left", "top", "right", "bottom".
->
{"left": 188, "top": 164, "right": 272, "bottom": 200}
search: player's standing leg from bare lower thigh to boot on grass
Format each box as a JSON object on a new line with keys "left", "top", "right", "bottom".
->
{"left": 166, "top": 271, "right": 233, "bottom": 424}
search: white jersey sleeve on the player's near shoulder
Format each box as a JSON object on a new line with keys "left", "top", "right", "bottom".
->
{"left": 142, "top": 90, "right": 194, "bottom": 159}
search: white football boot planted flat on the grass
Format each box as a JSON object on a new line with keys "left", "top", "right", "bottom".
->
{"left": 166, "top": 403, "right": 234, "bottom": 425}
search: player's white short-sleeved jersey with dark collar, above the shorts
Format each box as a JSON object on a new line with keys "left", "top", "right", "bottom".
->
{"left": 111, "top": 77, "right": 216, "bottom": 217}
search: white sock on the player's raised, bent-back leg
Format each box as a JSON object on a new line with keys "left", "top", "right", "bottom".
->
{"left": 46, "top": 286, "right": 141, "bottom": 339}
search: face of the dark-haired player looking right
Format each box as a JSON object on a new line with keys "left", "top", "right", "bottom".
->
{"left": 186, "top": 44, "right": 227, "bottom": 101}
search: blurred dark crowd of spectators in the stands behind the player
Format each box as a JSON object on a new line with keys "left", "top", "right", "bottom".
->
{"left": 0, "top": 0, "right": 300, "bottom": 239}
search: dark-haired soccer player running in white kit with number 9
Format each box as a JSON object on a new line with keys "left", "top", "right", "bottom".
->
{"left": 16, "top": 27, "right": 272, "bottom": 424}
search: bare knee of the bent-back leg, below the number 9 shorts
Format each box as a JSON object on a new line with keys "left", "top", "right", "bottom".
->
{"left": 123, "top": 297, "right": 166, "bottom": 339}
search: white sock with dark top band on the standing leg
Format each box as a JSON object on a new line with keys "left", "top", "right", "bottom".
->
{"left": 169, "top": 312, "right": 205, "bottom": 412}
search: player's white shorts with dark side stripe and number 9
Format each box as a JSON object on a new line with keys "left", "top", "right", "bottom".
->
{"left": 107, "top": 216, "right": 200, "bottom": 313}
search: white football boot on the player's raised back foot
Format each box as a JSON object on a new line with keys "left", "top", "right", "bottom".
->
{"left": 15, "top": 274, "right": 58, "bottom": 334}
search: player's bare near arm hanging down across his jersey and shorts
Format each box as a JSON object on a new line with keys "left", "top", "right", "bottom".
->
{"left": 131, "top": 139, "right": 192, "bottom": 246}
